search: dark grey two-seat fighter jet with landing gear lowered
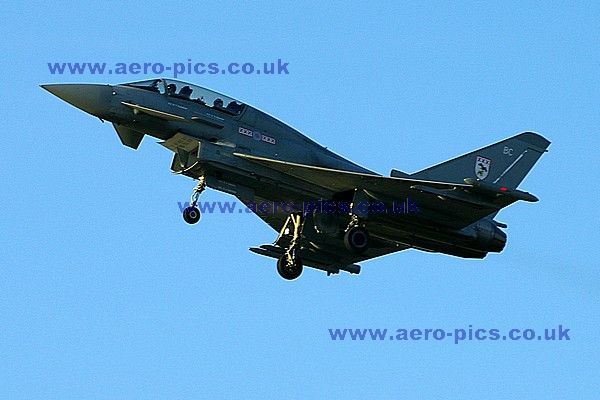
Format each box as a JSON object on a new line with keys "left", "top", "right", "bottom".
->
{"left": 42, "top": 79, "right": 550, "bottom": 280}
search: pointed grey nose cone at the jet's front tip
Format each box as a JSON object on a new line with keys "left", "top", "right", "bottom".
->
{"left": 40, "top": 83, "right": 112, "bottom": 118}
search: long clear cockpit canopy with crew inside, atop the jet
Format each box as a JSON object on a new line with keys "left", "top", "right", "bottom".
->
{"left": 124, "top": 79, "right": 245, "bottom": 115}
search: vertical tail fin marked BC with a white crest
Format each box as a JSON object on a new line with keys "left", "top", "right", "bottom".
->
{"left": 411, "top": 132, "right": 550, "bottom": 189}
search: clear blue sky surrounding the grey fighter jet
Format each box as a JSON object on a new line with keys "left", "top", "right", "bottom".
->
{"left": 0, "top": 1, "right": 600, "bottom": 399}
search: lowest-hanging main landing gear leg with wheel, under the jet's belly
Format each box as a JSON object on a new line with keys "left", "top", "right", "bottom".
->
{"left": 275, "top": 214, "right": 305, "bottom": 281}
